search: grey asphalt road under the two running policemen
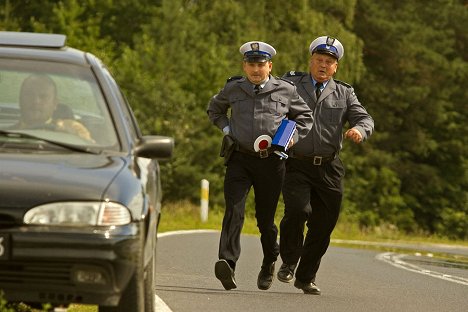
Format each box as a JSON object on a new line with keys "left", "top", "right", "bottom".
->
{"left": 156, "top": 232, "right": 468, "bottom": 312}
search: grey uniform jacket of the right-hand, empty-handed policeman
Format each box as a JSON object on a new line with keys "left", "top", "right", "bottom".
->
{"left": 284, "top": 72, "right": 374, "bottom": 156}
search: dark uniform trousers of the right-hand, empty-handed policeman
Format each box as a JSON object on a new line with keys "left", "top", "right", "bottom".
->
{"left": 280, "top": 157, "right": 344, "bottom": 283}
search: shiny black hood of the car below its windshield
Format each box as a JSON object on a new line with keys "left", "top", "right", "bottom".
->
{"left": 0, "top": 154, "right": 127, "bottom": 209}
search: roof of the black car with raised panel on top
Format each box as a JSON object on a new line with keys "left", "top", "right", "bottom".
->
{"left": 0, "top": 31, "right": 88, "bottom": 65}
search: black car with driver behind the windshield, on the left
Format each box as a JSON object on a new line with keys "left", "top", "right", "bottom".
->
{"left": 0, "top": 32, "right": 174, "bottom": 312}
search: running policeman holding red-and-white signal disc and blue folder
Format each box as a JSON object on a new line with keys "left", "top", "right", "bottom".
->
{"left": 207, "top": 41, "right": 313, "bottom": 290}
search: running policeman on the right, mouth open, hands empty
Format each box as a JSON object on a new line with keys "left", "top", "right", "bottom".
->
{"left": 277, "top": 36, "right": 374, "bottom": 295}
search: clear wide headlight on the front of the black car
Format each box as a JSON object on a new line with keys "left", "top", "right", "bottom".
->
{"left": 23, "top": 202, "right": 132, "bottom": 226}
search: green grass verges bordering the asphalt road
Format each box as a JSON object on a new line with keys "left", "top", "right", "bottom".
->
{"left": 6, "top": 201, "right": 468, "bottom": 312}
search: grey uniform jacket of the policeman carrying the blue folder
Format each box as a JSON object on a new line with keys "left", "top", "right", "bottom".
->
{"left": 207, "top": 76, "right": 313, "bottom": 151}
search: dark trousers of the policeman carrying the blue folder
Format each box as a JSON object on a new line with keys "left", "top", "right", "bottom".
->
{"left": 219, "top": 152, "right": 285, "bottom": 267}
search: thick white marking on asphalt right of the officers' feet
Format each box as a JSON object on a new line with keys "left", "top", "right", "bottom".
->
{"left": 375, "top": 252, "right": 468, "bottom": 286}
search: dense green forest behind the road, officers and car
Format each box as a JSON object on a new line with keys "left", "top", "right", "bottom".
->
{"left": 0, "top": 0, "right": 468, "bottom": 240}
